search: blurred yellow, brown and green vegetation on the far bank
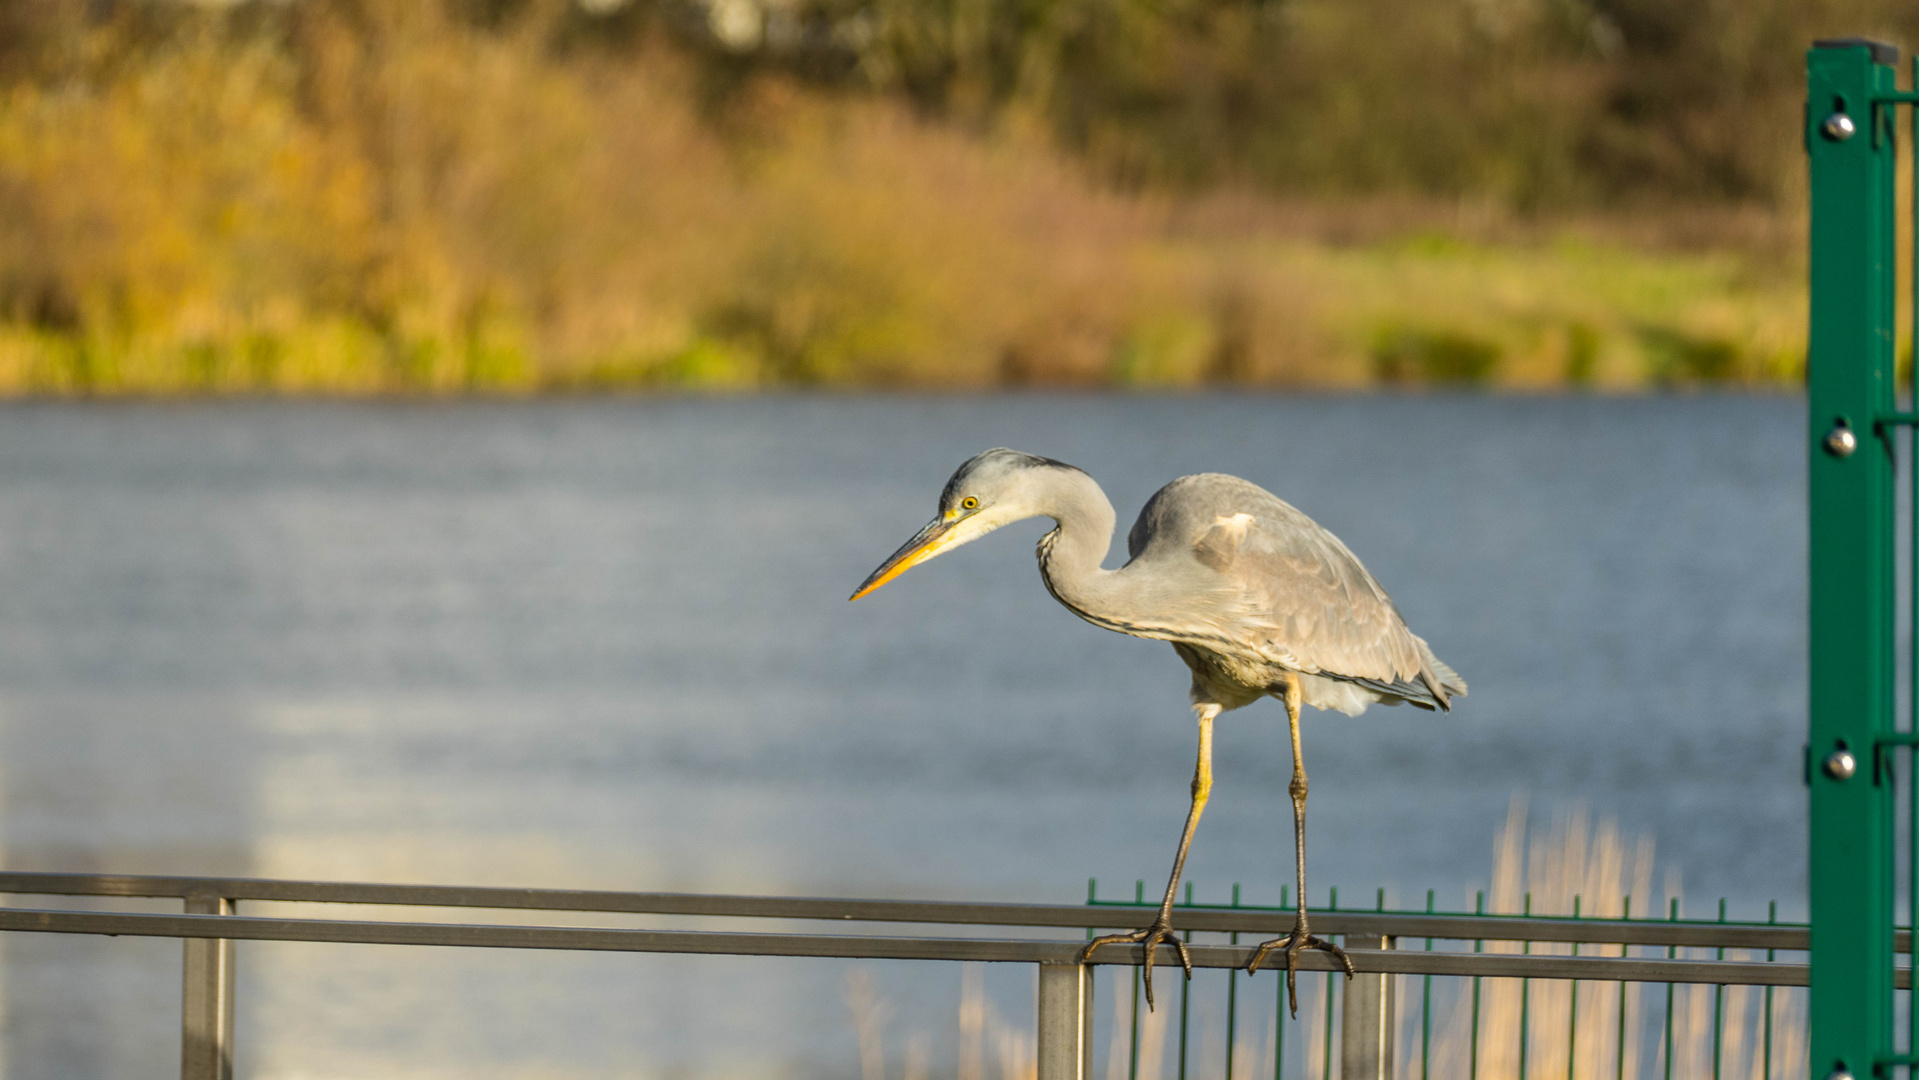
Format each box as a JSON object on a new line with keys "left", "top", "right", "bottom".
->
{"left": 0, "top": 0, "right": 1895, "bottom": 395}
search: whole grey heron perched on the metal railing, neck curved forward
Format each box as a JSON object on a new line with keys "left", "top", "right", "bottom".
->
{"left": 852, "top": 447, "right": 1466, "bottom": 1015}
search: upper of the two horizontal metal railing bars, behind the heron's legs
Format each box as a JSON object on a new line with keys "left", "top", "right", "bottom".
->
{"left": 0, "top": 871, "right": 1811, "bottom": 951}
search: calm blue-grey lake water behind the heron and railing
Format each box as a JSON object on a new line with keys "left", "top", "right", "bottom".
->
{"left": 0, "top": 395, "right": 1806, "bottom": 1080}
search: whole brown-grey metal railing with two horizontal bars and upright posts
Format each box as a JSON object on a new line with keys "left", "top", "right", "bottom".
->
{"left": 0, "top": 873, "right": 1819, "bottom": 1080}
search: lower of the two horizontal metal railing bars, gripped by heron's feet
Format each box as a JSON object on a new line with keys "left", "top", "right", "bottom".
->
{"left": 0, "top": 907, "right": 1826, "bottom": 986}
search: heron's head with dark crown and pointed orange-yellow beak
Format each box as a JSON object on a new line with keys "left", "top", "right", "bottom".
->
{"left": 850, "top": 447, "right": 1078, "bottom": 600}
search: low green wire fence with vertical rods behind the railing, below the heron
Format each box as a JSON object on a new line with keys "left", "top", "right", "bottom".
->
{"left": 1086, "top": 880, "right": 1803, "bottom": 1080}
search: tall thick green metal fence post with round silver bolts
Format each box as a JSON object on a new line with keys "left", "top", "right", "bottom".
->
{"left": 1804, "top": 40, "right": 1898, "bottom": 1078}
